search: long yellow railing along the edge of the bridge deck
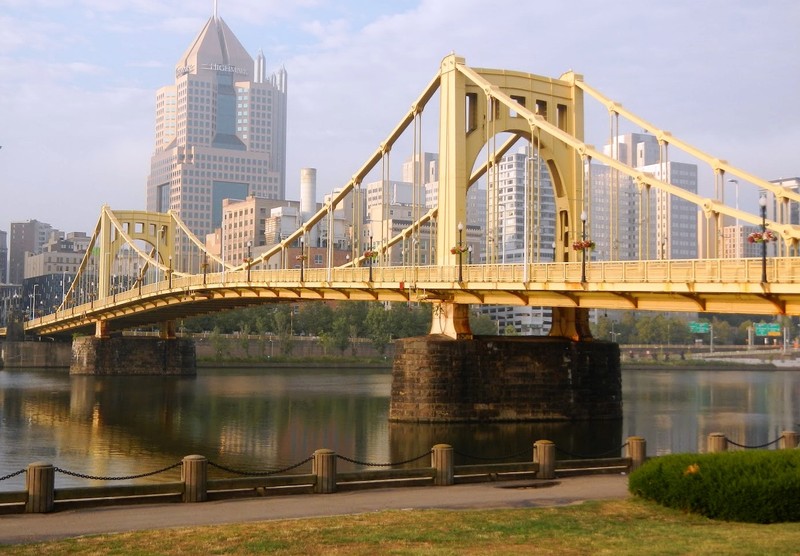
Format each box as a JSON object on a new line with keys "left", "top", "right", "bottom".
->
{"left": 21, "top": 257, "right": 800, "bottom": 326}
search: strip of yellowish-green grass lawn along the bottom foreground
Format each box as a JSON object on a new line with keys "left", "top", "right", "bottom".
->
{"left": 0, "top": 499, "right": 800, "bottom": 556}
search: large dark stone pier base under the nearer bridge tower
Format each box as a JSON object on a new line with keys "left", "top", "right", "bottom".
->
{"left": 389, "top": 335, "right": 622, "bottom": 422}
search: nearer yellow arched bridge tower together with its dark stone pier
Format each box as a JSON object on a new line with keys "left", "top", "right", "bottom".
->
{"left": 389, "top": 55, "right": 622, "bottom": 422}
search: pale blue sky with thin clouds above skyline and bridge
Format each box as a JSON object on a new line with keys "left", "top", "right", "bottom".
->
{"left": 0, "top": 0, "right": 800, "bottom": 235}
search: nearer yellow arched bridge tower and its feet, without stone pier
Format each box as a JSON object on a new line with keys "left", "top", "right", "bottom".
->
{"left": 431, "top": 55, "right": 591, "bottom": 340}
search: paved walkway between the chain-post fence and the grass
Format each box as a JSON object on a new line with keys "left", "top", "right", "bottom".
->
{"left": 0, "top": 475, "right": 628, "bottom": 545}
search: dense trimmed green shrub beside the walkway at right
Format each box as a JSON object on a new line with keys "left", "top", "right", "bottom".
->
{"left": 628, "top": 450, "right": 800, "bottom": 523}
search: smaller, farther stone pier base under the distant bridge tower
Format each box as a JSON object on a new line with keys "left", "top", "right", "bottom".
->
{"left": 69, "top": 336, "right": 197, "bottom": 376}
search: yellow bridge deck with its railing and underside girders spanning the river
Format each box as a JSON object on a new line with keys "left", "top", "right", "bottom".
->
{"left": 25, "top": 258, "right": 800, "bottom": 334}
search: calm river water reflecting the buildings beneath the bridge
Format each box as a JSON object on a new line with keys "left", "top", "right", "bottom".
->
{"left": 0, "top": 368, "right": 800, "bottom": 491}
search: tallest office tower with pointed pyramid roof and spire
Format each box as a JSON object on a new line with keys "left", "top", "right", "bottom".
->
{"left": 147, "top": 6, "right": 287, "bottom": 238}
